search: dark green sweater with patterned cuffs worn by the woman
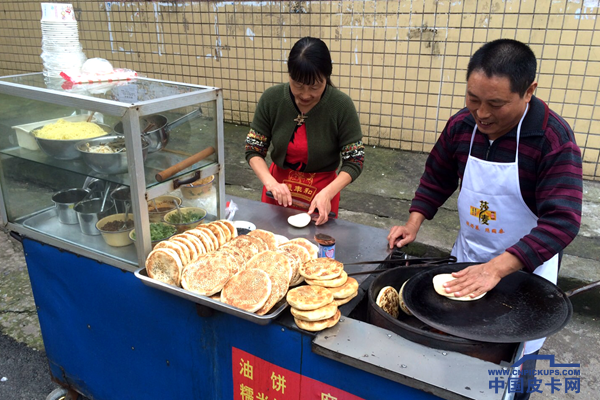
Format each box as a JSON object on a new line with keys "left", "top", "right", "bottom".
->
{"left": 246, "top": 83, "right": 364, "bottom": 180}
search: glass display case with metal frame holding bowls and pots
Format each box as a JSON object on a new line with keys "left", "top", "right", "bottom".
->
{"left": 0, "top": 73, "right": 225, "bottom": 271}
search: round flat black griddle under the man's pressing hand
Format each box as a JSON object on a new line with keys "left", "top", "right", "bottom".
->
{"left": 403, "top": 263, "right": 591, "bottom": 343}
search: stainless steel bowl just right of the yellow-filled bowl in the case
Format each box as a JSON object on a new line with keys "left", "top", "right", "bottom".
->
{"left": 75, "top": 135, "right": 150, "bottom": 175}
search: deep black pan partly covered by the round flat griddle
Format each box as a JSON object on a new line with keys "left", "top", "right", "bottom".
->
{"left": 367, "top": 265, "right": 517, "bottom": 363}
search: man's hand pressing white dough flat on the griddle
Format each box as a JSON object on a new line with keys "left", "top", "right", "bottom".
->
{"left": 444, "top": 252, "right": 523, "bottom": 298}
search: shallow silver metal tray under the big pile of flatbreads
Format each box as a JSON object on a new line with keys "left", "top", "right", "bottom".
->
{"left": 134, "top": 267, "right": 288, "bottom": 325}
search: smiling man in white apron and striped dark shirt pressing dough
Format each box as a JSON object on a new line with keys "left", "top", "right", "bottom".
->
{"left": 388, "top": 39, "right": 583, "bottom": 399}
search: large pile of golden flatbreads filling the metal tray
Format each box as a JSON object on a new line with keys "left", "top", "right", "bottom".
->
{"left": 146, "top": 220, "right": 318, "bottom": 315}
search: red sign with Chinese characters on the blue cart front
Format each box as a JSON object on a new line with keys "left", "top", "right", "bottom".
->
{"left": 231, "top": 347, "right": 363, "bottom": 400}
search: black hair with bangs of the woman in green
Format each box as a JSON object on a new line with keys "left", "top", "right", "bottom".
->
{"left": 288, "top": 36, "right": 333, "bottom": 85}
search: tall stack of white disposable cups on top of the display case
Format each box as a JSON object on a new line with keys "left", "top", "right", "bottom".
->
{"left": 41, "top": 3, "right": 87, "bottom": 78}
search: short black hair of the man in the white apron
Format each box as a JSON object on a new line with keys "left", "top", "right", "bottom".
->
{"left": 467, "top": 39, "right": 537, "bottom": 97}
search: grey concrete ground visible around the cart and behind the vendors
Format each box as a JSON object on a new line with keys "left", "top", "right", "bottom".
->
{"left": 0, "top": 124, "right": 600, "bottom": 400}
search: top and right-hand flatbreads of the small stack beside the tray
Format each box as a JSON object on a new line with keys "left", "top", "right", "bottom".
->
{"left": 300, "top": 258, "right": 358, "bottom": 306}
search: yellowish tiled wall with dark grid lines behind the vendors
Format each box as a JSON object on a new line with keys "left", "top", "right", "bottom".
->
{"left": 0, "top": 0, "right": 600, "bottom": 179}
